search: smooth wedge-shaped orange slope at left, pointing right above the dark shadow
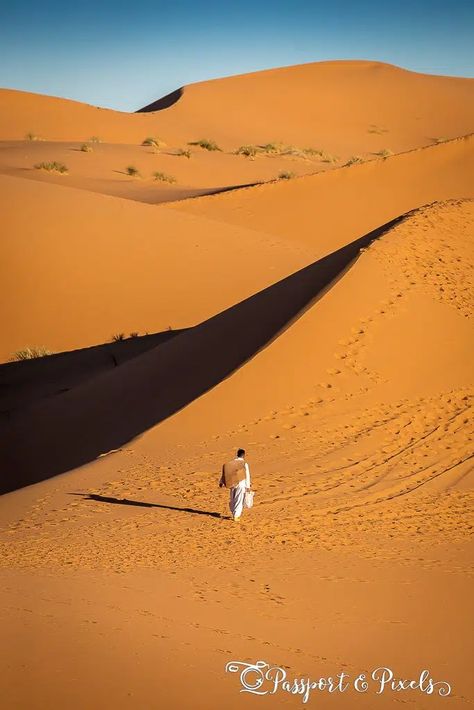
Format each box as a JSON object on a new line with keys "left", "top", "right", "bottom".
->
{"left": 0, "top": 176, "right": 312, "bottom": 360}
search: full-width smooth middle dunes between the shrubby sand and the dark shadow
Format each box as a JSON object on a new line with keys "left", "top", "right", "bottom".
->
{"left": 0, "top": 137, "right": 474, "bottom": 360}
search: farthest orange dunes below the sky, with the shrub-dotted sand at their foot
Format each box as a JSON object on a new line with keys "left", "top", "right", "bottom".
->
{"left": 0, "top": 61, "right": 474, "bottom": 203}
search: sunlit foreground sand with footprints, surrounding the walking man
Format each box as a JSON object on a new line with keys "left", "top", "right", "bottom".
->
{"left": 1, "top": 201, "right": 474, "bottom": 709}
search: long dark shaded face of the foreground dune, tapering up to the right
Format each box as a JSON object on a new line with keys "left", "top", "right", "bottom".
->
{"left": 0, "top": 216, "right": 404, "bottom": 493}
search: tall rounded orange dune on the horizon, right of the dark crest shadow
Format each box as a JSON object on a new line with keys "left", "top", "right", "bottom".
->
{"left": 138, "top": 61, "right": 474, "bottom": 153}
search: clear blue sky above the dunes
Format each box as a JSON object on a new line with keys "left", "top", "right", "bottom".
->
{"left": 0, "top": 0, "right": 474, "bottom": 111}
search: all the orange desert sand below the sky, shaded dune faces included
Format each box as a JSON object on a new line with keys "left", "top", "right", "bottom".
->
{"left": 0, "top": 61, "right": 474, "bottom": 710}
